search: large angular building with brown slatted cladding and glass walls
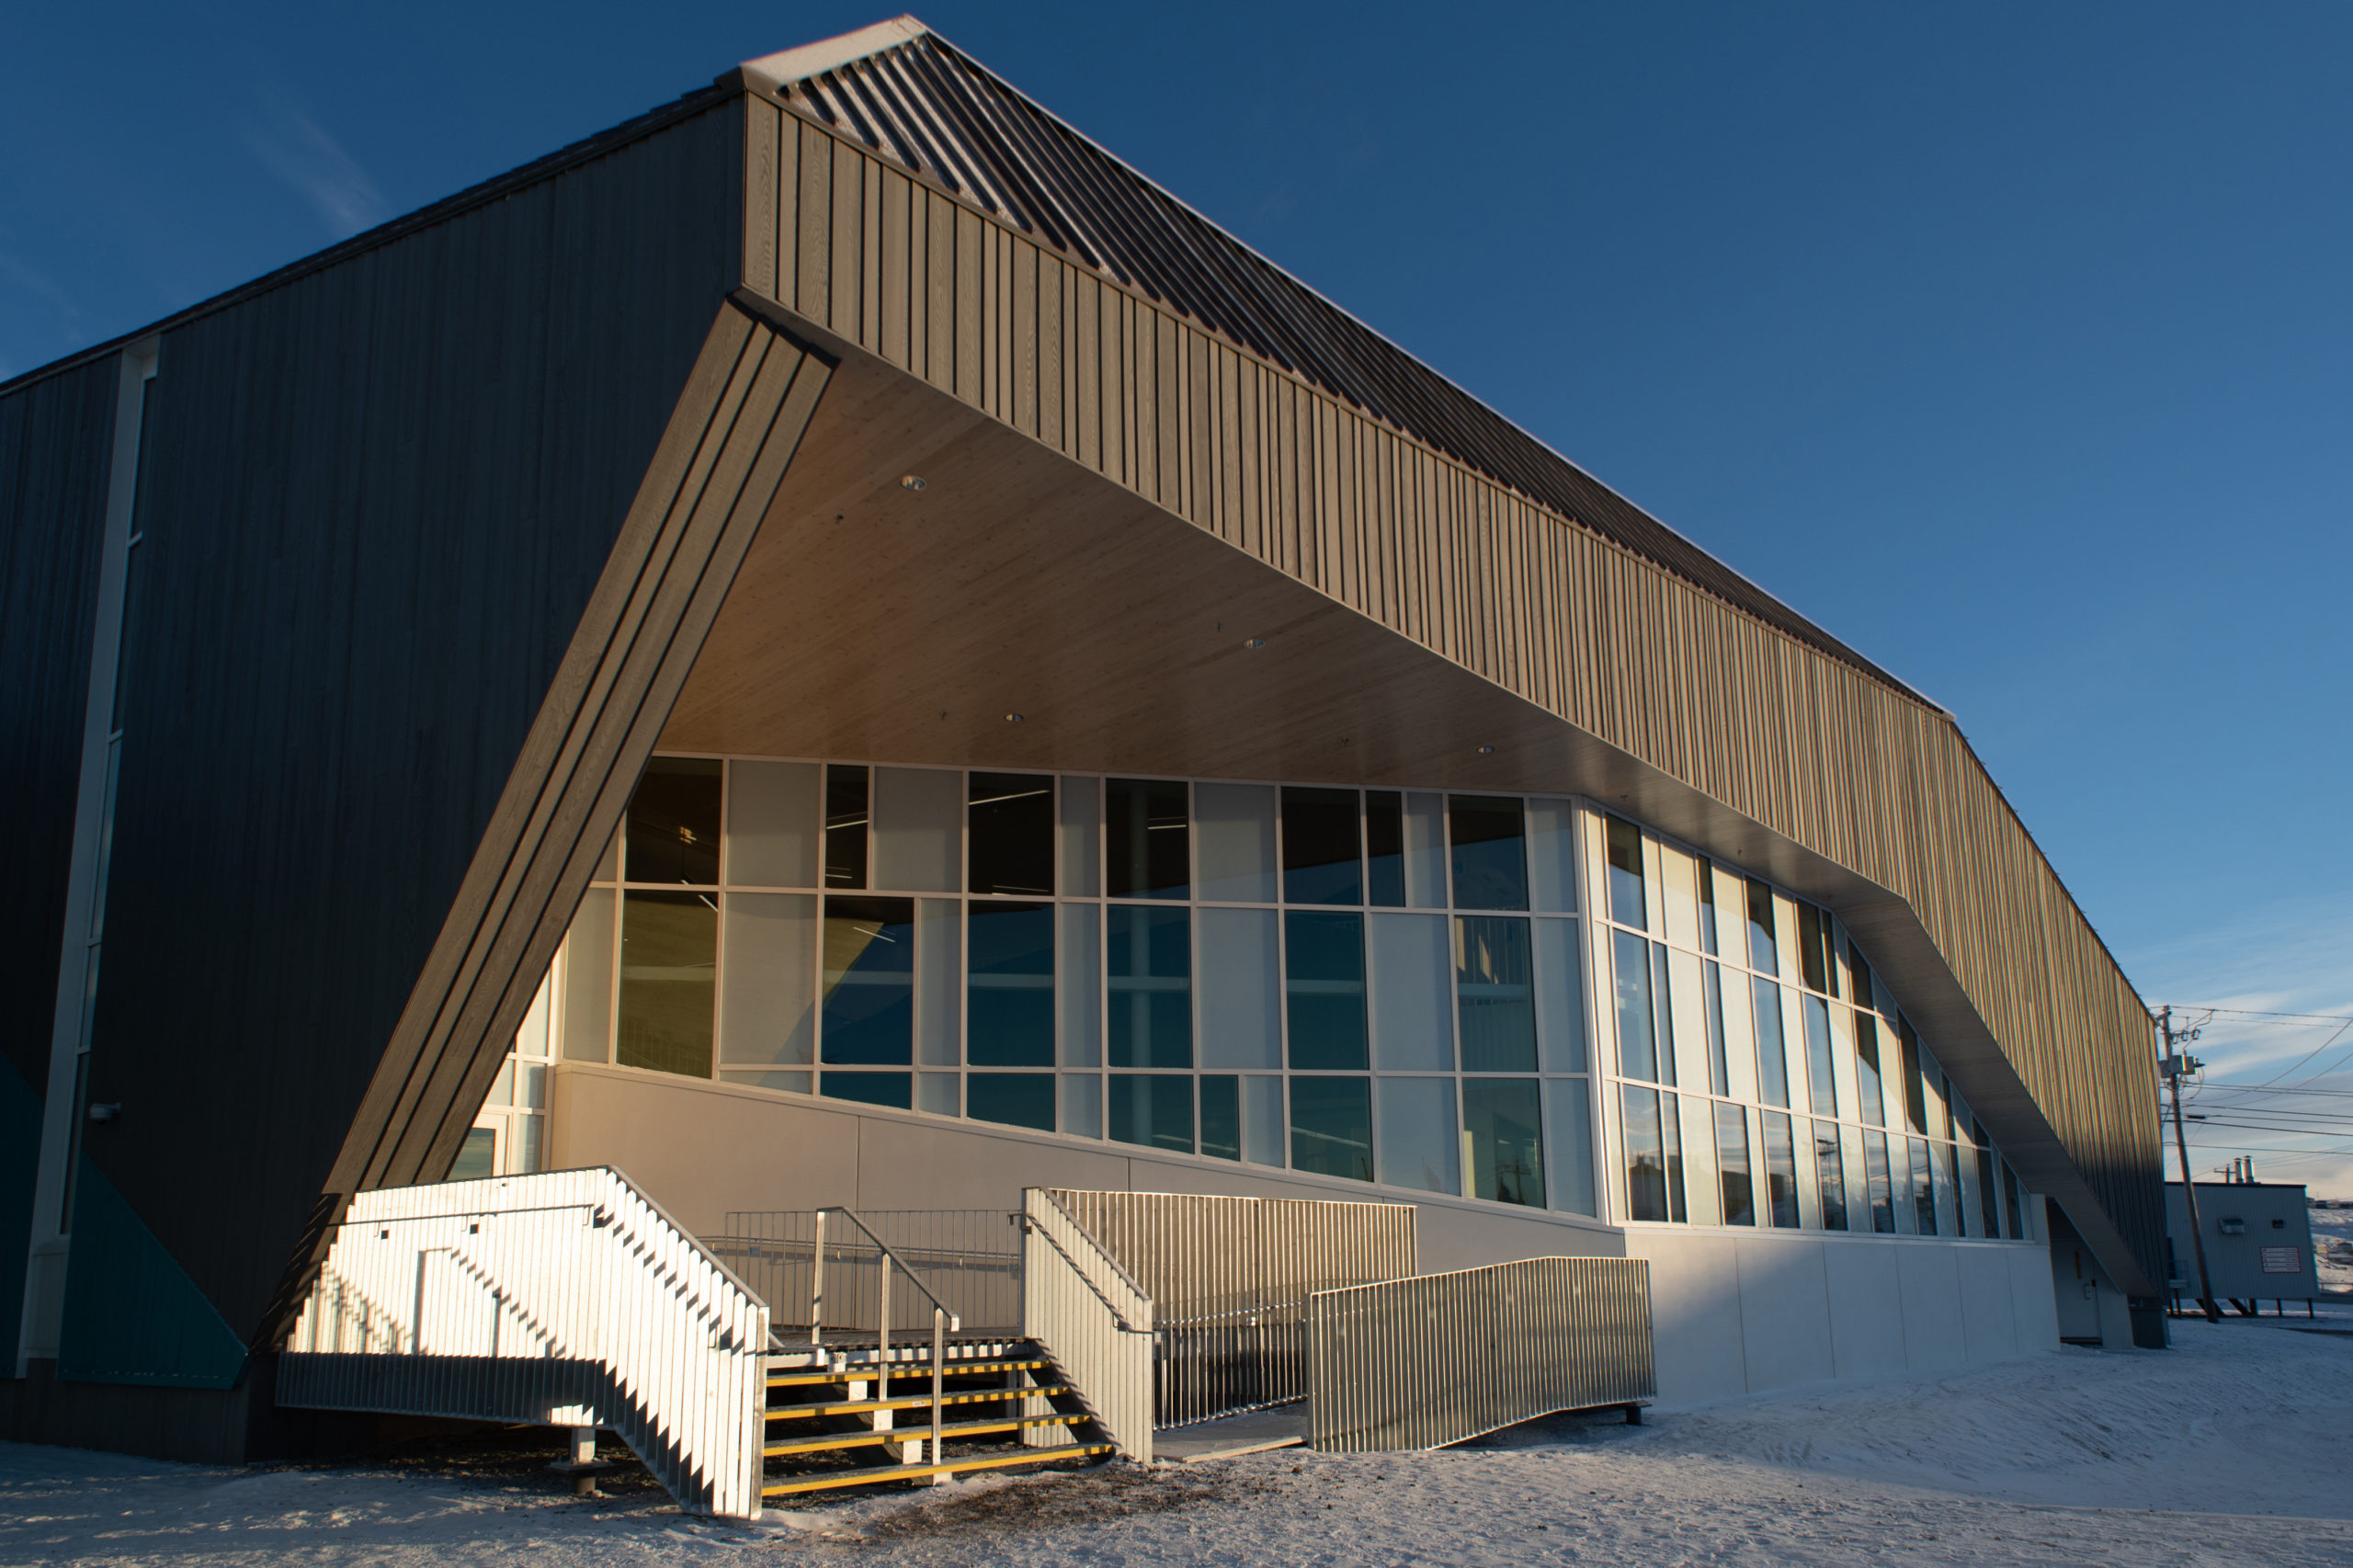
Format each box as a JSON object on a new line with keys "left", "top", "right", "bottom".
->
{"left": 0, "top": 18, "right": 2163, "bottom": 1452}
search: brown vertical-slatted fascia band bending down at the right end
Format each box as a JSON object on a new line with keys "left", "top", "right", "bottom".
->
{"left": 751, "top": 99, "right": 2163, "bottom": 1276}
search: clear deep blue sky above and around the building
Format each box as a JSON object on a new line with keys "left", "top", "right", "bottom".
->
{"left": 0, "top": 0, "right": 2353, "bottom": 1199}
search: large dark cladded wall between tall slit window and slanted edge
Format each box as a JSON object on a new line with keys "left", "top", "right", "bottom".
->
{"left": 68, "top": 99, "right": 744, "bottom": 1337}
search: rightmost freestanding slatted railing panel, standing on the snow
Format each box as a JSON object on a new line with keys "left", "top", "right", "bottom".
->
{"left": 1306, "top": 1257, "right": 1659, "bottom": 1452}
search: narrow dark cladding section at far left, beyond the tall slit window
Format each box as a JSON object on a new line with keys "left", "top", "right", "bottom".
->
{"left": 0, "top": 356, "right": 122, "bottom": 1092}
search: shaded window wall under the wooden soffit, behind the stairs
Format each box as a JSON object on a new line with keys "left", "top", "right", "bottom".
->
{"left": 563, "top": 756, "right": 1599, "bottom": 1217}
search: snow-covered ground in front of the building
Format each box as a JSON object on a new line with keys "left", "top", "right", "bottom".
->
{"left": 0, "top": 1307, "right": 2353, "bottom": 1568}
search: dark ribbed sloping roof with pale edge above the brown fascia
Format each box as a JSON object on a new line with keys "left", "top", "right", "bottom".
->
{"left": 718, "top": 14, "right": 1960, "bottom": 710}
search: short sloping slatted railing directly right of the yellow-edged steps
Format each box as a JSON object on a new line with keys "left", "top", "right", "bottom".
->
{"left": 1021, "top": 1187, "right": 1153, "bottom": 1464}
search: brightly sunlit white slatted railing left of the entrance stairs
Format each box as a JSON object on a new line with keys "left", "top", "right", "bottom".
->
{"left": 278, "top": 1168, "right": 767, "bottom": 1518}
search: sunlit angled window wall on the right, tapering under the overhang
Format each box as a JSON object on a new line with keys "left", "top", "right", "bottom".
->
{"left": 1586, "top": 814, "right": 2030, "bottom": 1241}
